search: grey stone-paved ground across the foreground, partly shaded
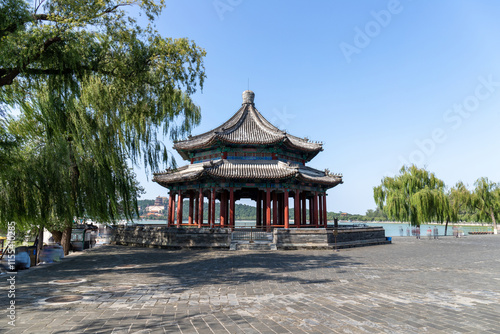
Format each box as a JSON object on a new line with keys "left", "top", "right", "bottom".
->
{"left": 0, "top": 235, "right": 500, "bottom": 334}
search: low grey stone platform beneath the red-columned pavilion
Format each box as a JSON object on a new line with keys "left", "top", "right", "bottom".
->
{"left": 111, "top": 225, "right": 391, "bottom": 250}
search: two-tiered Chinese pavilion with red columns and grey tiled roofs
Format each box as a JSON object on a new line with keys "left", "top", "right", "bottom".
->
{"left": 153, "top": 90, "right": 343, "bottom": 228}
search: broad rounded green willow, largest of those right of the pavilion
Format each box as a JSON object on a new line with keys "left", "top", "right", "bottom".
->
{"left": 373, "top": 165, "right": 450, "bottom": 226}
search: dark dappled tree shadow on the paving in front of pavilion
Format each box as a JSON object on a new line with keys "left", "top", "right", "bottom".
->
{"left": 1, "top": 246, "right": 363, "bottom": 333}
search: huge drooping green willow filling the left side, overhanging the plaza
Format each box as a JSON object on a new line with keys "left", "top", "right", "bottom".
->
{"left": 0, "top": 0, "right": 205, "bottom": 254}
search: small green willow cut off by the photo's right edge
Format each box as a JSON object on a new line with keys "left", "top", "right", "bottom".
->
{"left": 471, "top": 177, "right": 500, "bottom": 234}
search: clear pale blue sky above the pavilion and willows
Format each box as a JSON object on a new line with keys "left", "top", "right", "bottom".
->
{"left": 136, "top": 0, "right": 500, "bottom": 214}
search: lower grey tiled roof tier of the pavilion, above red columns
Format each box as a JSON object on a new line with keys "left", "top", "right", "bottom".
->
{"left": 153, "top": 159, "right": 342, "bottom": 187}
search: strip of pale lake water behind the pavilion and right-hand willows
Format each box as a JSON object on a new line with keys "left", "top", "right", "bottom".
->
{"left": 130, "top": 220, "right": 492, "bottom": 237}
